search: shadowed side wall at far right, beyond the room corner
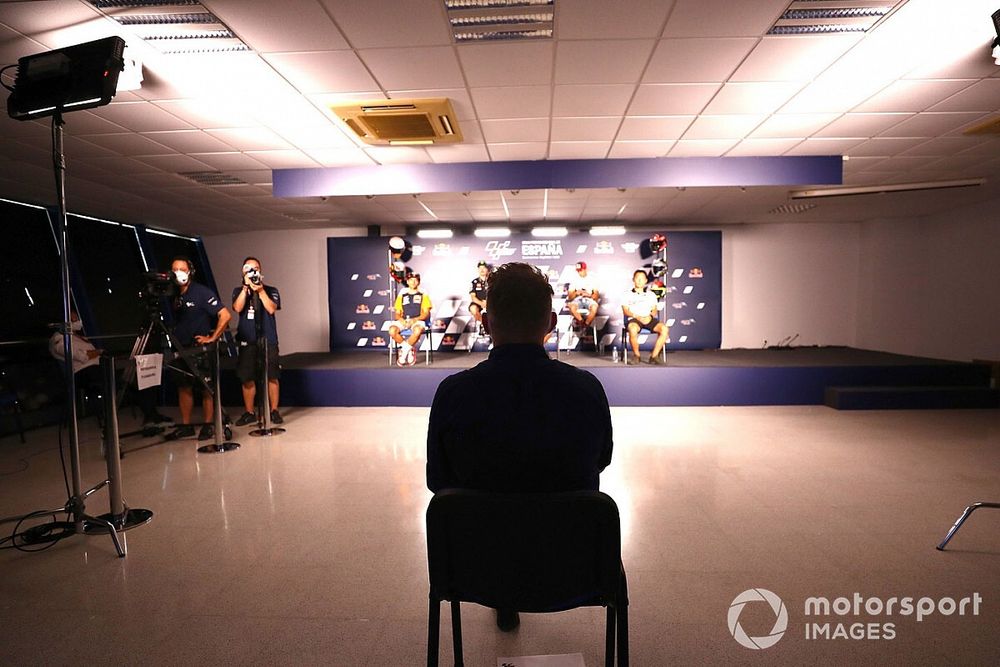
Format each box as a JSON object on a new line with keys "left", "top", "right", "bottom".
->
{"left": 858, "top": 205, "right": 1000, "bottom": 361}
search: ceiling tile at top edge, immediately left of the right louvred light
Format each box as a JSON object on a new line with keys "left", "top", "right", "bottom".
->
{"left": 663, "top": 0, "right": 788, "bottom": 37}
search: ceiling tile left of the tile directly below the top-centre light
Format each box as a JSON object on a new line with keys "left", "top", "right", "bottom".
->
{"left": 359, "top": 46, "right": 465, "bottom": 90}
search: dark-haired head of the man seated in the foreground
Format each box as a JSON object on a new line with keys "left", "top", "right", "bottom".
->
{"left": 485, "top": 262, "right": 556, "bottom": 345}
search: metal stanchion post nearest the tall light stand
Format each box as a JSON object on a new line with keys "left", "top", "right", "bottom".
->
{"left": 84, "top": 356, "right": 153, "bottom": 558}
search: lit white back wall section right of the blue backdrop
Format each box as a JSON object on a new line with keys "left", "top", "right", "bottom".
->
{"left": 722, "top": 223, "right": 859, "bottom": 348}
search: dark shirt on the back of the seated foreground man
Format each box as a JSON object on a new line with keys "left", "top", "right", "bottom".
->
{"left": 427, "top": 344, "right": 612, "bottom": 492}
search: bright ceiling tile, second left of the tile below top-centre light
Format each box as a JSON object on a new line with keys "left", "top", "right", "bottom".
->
{"left": 264, "top": 51, "right": 378, "bottom": 94}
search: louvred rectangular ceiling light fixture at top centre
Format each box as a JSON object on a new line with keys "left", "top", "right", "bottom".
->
{"left": 444, "top": 0, "right": 555, "bottom": 44}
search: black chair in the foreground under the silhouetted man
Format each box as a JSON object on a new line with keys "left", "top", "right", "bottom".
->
{"left": 427, "top": 489, "right": 628, "bottom": 667}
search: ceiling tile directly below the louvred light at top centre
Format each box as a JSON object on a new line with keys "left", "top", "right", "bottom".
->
{"left": 458, "top": 41, "right": 555, "bottom": 88}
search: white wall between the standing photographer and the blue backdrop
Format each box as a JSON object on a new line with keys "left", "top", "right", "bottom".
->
{"left": 204, "top": 227, "right": 367, "bottom": 354}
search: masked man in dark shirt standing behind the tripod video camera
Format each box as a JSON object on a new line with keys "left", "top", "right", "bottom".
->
{"left": 168, "top": 256, "right": 232, "bottom": 440}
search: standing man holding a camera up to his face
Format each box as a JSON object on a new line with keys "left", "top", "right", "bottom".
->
{"left": 233, "top": 257, "right": 284, "bottom": 426}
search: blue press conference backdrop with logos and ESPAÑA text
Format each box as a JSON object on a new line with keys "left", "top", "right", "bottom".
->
{"left": 327, "top": 232, "right": 722, "bottom": 351}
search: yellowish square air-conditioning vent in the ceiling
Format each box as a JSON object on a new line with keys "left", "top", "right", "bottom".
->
{"left": 330, "top": 97, "right": 462, "bottom": 146}
